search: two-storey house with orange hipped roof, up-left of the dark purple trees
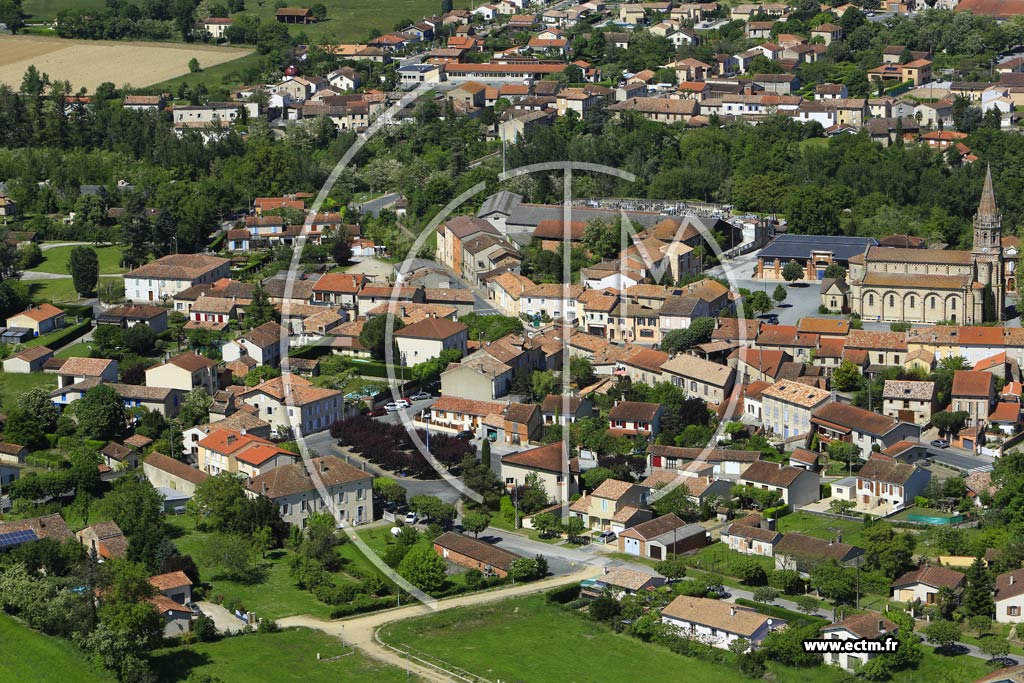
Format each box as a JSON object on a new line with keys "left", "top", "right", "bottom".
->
{"left": 242, "top": 374, "right": 345, "bottom": 434}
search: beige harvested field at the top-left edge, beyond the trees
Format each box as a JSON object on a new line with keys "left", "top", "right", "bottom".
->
{"left": 0, "top": 36, "right": 251, "bottom": 91}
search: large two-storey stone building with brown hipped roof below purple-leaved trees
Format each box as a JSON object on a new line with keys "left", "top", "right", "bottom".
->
{"left": 248, "top": 456, "right": 374, "bottom": 528}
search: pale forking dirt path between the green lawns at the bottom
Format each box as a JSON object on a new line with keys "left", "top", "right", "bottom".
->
{"left": 278, "top": 566, "right": 601, "bottom": 683}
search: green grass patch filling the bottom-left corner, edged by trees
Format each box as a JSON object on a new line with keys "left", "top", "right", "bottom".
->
{"left": 0, "top": 612, "right": 114, "bottom": 683}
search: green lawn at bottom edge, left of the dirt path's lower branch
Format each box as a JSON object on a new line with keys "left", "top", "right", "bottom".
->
{"left": 149, "top": 629, "right": 409, "bottom": 683}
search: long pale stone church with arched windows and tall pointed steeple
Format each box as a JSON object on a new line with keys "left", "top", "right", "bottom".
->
{"left": 848, "top": 168, "right": 1006, "bottom": 325}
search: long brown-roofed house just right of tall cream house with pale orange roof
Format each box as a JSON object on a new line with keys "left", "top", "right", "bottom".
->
{"left": 811, "top": 401, "right": 921, "bottom": 459}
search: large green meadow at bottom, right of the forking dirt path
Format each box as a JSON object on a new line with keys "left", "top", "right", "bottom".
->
{"left": 380, "top": 596, "right": 844, "bottom": 683}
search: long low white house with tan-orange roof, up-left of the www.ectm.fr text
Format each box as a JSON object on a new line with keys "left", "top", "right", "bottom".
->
{"left": 662, "top": 595, "right": 785, "bottom": 649}
